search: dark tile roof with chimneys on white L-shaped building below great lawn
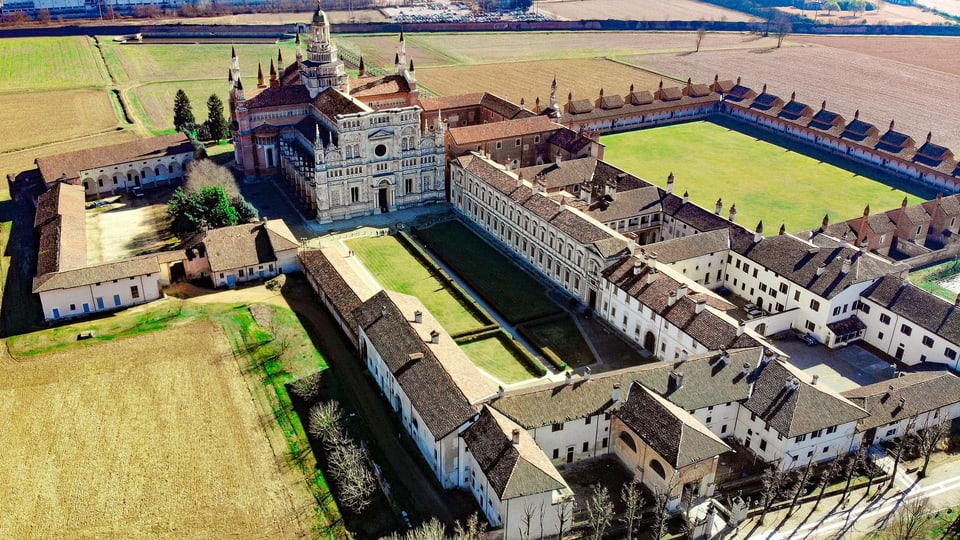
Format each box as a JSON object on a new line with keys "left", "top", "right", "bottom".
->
{"left": 730, "top": 227, "right": 904, "bottom": 299}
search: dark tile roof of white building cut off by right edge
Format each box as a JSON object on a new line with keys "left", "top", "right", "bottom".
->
{"left": 862, "top": 276, "right": 960, "bottom": 344}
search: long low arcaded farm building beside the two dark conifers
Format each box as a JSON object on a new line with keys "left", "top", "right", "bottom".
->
{"left": 36, "top": 133, "right": 196, "bottom": 198}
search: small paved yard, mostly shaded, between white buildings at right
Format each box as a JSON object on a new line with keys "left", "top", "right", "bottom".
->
{"left": 775, "top": 339, "right": 894, "bottom": 392}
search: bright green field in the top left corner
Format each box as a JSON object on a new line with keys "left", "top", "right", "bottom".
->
{"left": 0, "top": 36, "right": 110, "bottom": 90}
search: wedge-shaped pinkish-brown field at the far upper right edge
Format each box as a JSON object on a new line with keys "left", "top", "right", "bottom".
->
{"left": 790, "top": 35, "right": 960, "bottom": 76}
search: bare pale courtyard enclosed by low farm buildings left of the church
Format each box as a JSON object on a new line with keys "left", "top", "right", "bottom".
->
{"left": 86, "top": 192, "right": 176, "bottom": 264}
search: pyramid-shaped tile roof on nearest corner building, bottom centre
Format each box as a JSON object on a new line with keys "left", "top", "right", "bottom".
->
{"left": 461, "top": 407, "right": 570, "bottom": 501}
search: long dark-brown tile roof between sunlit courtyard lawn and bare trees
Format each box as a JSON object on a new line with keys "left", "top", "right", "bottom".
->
{"left": 353, "top": 291, "right": 476, "bottom": 440}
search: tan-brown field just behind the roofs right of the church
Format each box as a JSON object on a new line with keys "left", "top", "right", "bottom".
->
{"left": 417, "top": 58, "right": 660, "bottom": 109}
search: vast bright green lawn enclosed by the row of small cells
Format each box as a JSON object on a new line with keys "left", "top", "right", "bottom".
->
{"left": 602, "top": 122, "right": 923, "bottom": 234}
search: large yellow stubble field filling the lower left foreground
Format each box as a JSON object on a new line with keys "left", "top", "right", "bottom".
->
{"left": 0, "top": 323, "right": 312, "bottom": 538}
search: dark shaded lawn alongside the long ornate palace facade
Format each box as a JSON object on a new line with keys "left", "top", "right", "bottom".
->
{"left": 417, "top": 221, "right": 560, "bottom": 323}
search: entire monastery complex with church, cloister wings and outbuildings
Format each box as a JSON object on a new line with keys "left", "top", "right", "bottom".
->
{"left": 24, "top": 9, "right": 960, "bottom": 538}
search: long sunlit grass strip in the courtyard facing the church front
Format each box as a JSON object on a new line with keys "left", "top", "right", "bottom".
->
{"left": 348, "top": 236, "right": 483, "bottom": 334}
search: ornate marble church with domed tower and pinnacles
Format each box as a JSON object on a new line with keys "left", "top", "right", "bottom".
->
{"left": 228, "top": 4, "right": 445, "bottom": 224}
